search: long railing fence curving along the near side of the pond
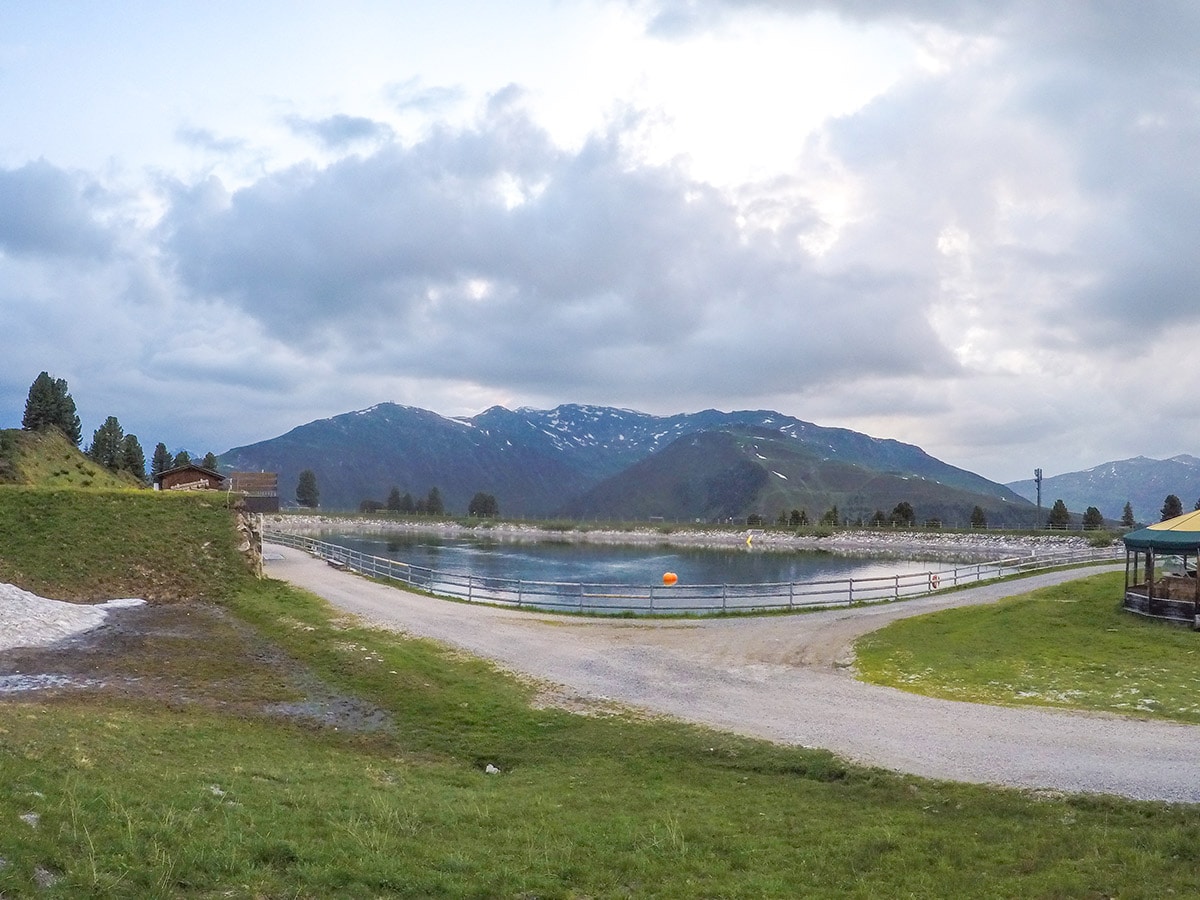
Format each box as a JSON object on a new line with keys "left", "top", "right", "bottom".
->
{"left": 263, "top": 532, "right": 1124, "bottom": 614}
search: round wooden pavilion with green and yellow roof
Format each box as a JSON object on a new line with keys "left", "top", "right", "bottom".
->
{"left": 1124, "top": 510, "right": 1200, "bottom": 628}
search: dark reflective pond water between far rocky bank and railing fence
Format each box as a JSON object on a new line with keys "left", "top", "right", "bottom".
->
{"left": 322, "top": 534, "right": 946, "bottom": 584}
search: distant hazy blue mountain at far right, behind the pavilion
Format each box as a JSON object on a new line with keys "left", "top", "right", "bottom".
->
{"left": 1008, "top": 454, "right": 1200, "bottom": 522}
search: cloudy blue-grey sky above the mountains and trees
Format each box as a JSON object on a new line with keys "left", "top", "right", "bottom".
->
{"left": 0, "top": 0, "right": 1200, "bottom": 482}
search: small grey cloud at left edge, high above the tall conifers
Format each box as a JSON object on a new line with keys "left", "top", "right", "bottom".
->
{"left": 0, "top": 160, "right": 113, "bottom": 257}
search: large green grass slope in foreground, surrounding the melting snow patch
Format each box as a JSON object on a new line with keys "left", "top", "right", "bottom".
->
{"left": 0, "top": 490, "right": 1200, "bottom": 898}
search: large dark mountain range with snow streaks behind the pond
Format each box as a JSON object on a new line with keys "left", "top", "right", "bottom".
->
{"left": 220, "top": 403, "right": 1036, "bottom": 526}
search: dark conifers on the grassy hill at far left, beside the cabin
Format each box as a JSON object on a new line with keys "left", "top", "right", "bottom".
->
{"left": 20, "top": 372, "right": 217, "bottom": 484}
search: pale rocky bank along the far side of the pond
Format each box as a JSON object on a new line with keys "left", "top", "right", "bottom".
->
{"left": 264, "top": 515, "right": 1108, "bottom": 560}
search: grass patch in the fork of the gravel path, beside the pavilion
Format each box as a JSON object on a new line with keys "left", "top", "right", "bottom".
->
{"left": 856, "top": 574, "right": 1200, "bottom": 722}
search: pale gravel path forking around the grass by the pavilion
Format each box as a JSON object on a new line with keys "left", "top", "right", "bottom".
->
{"left": 268, "top": 546, "right": 1200, "bottom": 803}
